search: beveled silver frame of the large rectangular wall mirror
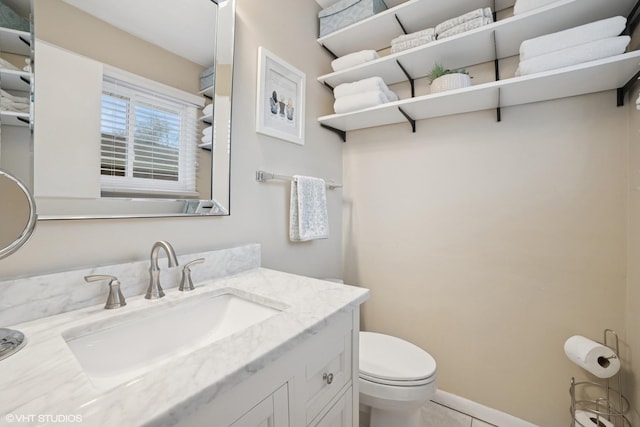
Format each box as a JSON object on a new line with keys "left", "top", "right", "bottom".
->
{"left": 32, "top": 0, "right": 237, "bottom": 220}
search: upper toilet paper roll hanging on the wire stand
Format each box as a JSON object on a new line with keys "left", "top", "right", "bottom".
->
{"left": 564, "top": 335, "right": 620, "bottom": 378}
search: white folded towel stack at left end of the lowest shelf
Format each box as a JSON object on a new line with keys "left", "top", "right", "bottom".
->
{"left": 333, "top": 77, "right": 398, "bottom": 114}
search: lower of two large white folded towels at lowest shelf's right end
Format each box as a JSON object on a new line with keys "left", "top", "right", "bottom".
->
{"left": 516, "top": 36, "right": 631, "bottom": 76}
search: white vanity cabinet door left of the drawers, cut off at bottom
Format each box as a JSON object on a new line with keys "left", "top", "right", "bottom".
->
{"left": 231, "top": 384, "right": 289, "bottom": 427}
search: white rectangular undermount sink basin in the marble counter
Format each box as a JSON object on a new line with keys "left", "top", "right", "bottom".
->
{"left": 63, "top": 291, "right": 281, "bottom": 388}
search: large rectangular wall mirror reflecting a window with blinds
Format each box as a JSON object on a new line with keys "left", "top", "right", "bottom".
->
{"left": 25, "top": 0, "right": 235, "bottom": 219}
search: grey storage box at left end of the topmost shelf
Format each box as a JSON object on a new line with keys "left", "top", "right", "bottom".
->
{"left": 318, "top": 0, "right": 387, "bottom": 37}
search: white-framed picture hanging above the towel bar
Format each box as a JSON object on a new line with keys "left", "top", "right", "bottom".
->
{"left": 256, "top": 46, "right": 306, "bottom": 145}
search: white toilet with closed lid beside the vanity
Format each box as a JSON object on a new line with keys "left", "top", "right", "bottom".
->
{"left": 358, "top": 332, "right": 437, "bottom": 427}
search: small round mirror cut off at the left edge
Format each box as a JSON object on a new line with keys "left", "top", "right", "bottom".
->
{"left": 0, "top": 170, "right": 37, "bottom": 258}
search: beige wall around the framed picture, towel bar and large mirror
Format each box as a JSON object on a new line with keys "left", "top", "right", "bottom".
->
{"left": 0, "top": 0, "right": 342, "bottom": 287}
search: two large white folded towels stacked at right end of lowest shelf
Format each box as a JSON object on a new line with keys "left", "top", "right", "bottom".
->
{"left": 516, "top": 16, "right": 631, "bottom": 76}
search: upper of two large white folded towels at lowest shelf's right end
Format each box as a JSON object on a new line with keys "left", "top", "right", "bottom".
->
{"left": 520, "top": 16, "right": 627, "bottom": 61}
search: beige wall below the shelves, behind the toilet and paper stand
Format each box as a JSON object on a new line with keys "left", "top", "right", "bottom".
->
{"left": 344, "top": 85, "right": 627, "bottom": 427}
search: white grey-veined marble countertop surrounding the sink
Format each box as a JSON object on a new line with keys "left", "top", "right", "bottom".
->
{"left": 0, "top": 268, "right": 369, "bottom": 426}
